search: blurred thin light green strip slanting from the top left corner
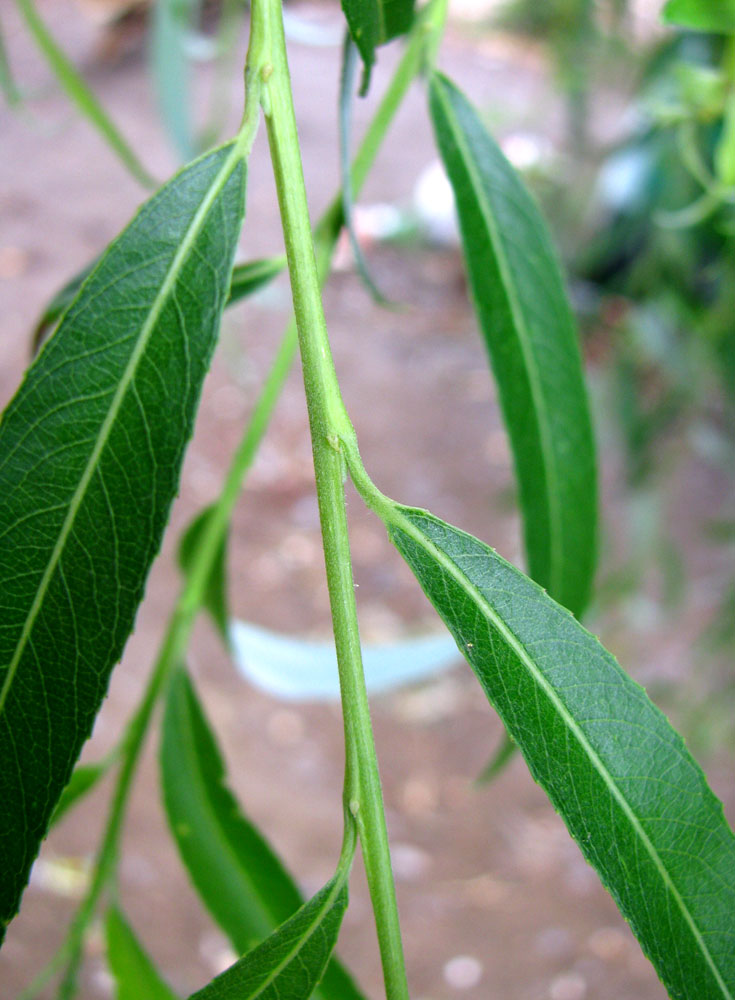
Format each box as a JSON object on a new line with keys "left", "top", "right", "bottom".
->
{"left": 16, "top": 0, "right": 155, "bottom": 187}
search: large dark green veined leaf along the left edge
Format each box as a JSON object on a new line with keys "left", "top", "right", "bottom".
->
{"left": 0, "top": 146, "right": 245, "bottom": 928}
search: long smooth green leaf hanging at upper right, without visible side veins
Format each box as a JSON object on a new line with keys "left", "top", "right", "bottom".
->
{"left": 430, "top": 74, "right": 597, "bottom": 616}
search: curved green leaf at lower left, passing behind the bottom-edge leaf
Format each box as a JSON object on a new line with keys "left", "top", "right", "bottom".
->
{"left": 161, "top": 671, "right": 361, "bottom": 1000}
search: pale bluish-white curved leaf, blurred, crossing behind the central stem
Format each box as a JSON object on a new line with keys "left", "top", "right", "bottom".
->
{"left": 230, "top": 621, "right": 457, "bottom": 701}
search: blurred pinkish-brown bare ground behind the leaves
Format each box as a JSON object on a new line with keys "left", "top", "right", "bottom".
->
{"left": 0, "top": 0, "right": 735, "bottom": 1000}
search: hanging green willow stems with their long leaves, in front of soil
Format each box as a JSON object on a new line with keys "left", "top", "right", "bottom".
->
{"left": 0, "top": 0, "right": 735, "bottom": 1000}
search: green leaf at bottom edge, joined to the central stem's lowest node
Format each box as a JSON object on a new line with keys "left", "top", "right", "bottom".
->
{"left": 189, "top": 876, "right": 347, "bottom": 1000}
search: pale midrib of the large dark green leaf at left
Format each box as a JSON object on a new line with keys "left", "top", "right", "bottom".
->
{"left": 0, "top": 144, "right": 241, "bottom": 716}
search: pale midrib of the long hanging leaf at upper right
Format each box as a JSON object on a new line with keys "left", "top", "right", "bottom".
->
{"left": 435, "top": 78, "right": 564, "bottom": 597}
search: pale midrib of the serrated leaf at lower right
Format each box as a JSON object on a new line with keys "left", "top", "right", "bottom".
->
{"left": 392, "top": 507, "right": 735, "bottom": 1000}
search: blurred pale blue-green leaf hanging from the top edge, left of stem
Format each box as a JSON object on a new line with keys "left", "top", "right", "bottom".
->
{"left": 150, "top": 0, "right": 200, "bottom": 161}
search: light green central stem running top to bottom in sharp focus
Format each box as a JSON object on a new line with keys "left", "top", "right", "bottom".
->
{"left": 251, "top": 0, "right": 408, "bottom": 1000}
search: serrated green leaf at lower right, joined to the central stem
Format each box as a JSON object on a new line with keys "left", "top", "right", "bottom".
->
{"left": 383, "top": 506, "right": 735, "bottom": 1000}
